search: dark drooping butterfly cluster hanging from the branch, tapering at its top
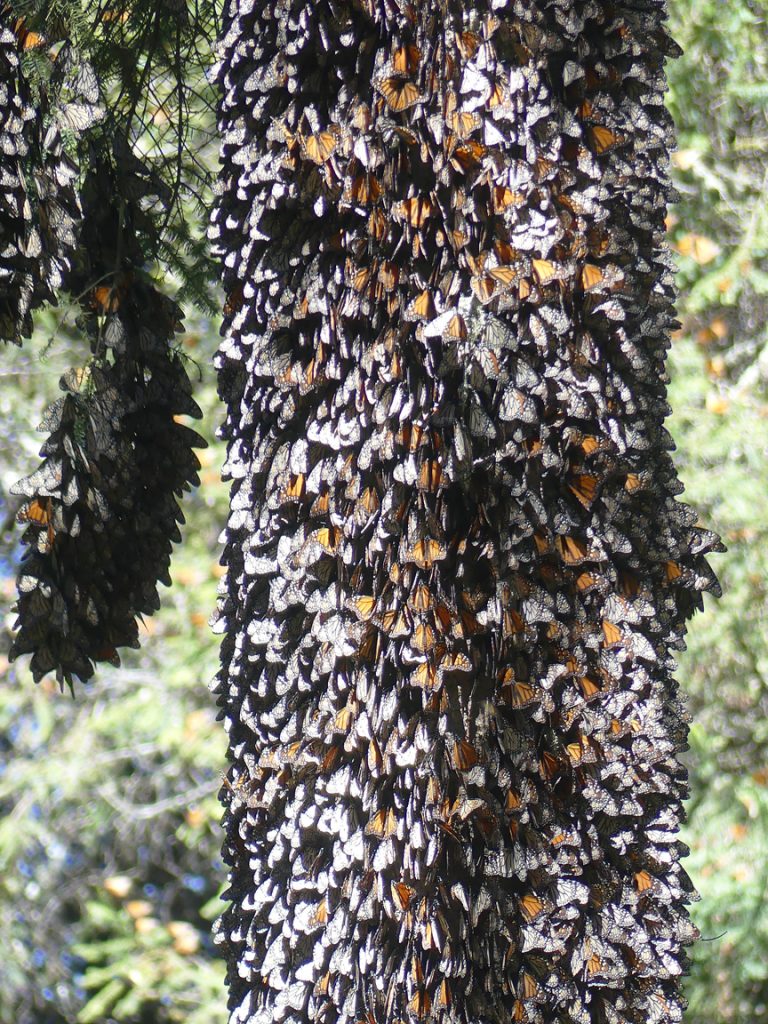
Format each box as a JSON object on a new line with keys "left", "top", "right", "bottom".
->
{"left": 11, "top": 157, "right": 205, "bottom": 684}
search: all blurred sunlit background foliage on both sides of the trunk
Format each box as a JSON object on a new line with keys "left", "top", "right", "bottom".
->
{"left": 0, "top": 0, "right": 768, "bottom": 1024}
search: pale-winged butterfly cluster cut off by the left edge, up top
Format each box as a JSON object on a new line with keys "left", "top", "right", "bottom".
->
{"left": 0, "top": 17, "right": 80, "bottom": 344}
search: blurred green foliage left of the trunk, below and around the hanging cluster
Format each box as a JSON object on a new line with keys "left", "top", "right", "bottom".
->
{"left": 0, "top": 311, "right": 226, "bottom": 1024}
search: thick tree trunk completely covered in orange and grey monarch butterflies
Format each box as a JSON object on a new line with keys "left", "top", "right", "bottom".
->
{"left": 211, "top": 0, "right": 718, "bottom": 1024}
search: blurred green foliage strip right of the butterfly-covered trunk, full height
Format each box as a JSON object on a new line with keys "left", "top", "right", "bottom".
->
{"left": 670, "top": 0, "right": 768, "bottom": 1024}
